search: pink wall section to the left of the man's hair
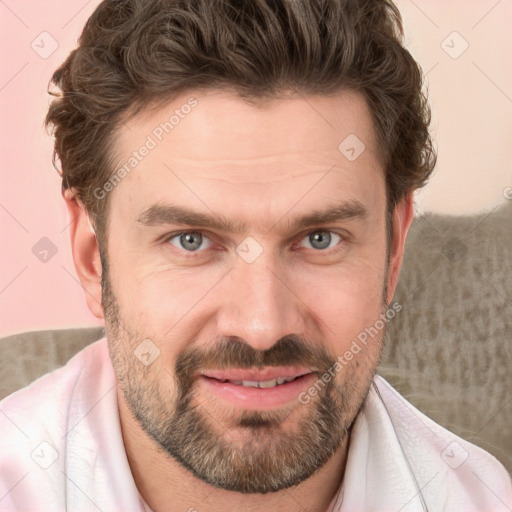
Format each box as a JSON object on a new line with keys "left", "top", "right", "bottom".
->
{"left": 0, "top": 0, "right": 105, "bottom": 336}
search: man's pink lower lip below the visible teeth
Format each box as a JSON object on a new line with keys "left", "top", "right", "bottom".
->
{"left": 198, "top": 373, "right": 315, "bottom": 410}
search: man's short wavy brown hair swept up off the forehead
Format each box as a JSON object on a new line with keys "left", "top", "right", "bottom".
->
{"left": 46, "top": 0, "right": 436, "bottom": 252}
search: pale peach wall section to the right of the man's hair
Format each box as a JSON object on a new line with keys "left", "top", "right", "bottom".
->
{"left": 396, "top": 0, "right": 512, "bottom": 213}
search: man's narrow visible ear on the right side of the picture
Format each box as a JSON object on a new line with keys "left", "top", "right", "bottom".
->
{"left": 387, "top": 191, "right": 414, "bottom": 304}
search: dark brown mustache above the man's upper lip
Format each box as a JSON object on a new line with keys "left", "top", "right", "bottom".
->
{"left": 175, "top": 335, "right": 336, "bottom": 382}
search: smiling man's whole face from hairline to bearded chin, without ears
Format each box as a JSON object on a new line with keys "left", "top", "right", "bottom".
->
{"left": 103, "top": 91, "right": 394, "bottom": 492}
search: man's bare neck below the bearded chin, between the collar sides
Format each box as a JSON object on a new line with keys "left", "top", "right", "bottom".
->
{"left": 118, "top": 390, "right": 349, "bottom": 512}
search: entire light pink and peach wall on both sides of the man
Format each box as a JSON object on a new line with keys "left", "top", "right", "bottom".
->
{"left": 0, "top": 0, "right": 512, "bottom": 336}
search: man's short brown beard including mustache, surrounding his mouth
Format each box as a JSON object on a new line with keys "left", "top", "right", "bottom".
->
{"left": 102, "top": 250, "right": 383, "bottom": 493}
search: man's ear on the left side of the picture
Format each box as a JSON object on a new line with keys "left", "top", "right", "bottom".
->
{"left": 62, "top": 189, "right": 103, "bottom": 319}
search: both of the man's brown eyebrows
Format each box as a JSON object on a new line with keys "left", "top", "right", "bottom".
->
{"left": 137, "top": 200, "right": 368, "bottom": 233}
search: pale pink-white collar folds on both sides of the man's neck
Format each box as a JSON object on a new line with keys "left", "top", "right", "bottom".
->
{"left": 70, "top": 339, "right": 427, "bottom": 512}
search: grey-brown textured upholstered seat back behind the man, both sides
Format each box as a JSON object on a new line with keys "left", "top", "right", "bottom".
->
{"left": 0, "top": 202, "right": 512, "bottom": 472}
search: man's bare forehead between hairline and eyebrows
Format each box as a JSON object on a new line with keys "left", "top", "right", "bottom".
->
{"left": 111, "top": 87, "right": 384, "bottom": 222}
